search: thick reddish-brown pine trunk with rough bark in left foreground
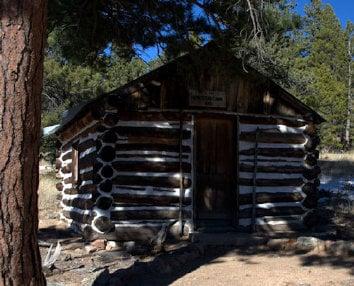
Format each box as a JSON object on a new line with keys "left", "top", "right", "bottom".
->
{"left": 0, "top": 0, "right": 46, "bottom": 286}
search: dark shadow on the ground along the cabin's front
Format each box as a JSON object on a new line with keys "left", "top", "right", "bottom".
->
{"left": 93, "top": 241, "right": 354, "bottom": 286}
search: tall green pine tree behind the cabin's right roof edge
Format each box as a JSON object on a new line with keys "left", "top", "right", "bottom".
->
{"left": 290, "top": 0, "right": 349, "bottom": 150}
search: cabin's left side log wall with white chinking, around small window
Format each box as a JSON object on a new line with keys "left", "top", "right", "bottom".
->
{"left": 56, "top": 120, "right": 99, "bottom": 236}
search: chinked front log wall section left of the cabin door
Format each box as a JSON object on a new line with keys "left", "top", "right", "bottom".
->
{"left": 92, "top": 110, "right": 193, "bottom": 240}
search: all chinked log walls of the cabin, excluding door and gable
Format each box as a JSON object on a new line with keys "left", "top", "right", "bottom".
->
{"left": 57, "top": 109, "right": 320, "bottom": 237}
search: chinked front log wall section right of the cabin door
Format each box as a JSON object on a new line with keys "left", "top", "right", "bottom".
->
{"left": 238, "top": 116, "right": 320, "bottom": 231}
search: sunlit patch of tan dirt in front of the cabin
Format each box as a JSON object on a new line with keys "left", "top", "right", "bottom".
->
{"left": 171, "top": 254, "right": 354, "bottom": 286}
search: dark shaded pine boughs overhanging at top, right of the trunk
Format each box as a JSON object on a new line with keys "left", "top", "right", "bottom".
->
{"left": 49, "top": 0, "right": 214, "bottom": 64}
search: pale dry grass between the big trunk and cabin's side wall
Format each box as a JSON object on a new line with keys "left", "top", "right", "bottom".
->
{"left": 38, "top": 173, "right": 60, "bottom": 219}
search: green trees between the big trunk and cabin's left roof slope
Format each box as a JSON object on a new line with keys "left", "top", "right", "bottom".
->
{"left": 42, "top": 55, "right": 148, "bottom": 126}
